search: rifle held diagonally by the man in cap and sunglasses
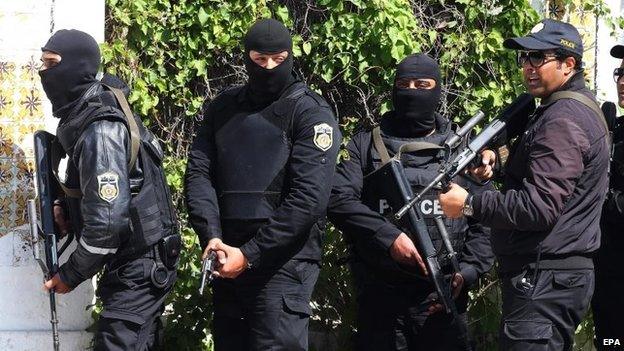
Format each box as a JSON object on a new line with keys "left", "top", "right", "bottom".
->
{"left": 395, "top": 93, "right": 535, "bottom": 220}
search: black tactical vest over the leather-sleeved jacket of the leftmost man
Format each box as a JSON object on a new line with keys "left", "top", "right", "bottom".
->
{"left": 56, "top": 83, "right": 178, "bottom": 257}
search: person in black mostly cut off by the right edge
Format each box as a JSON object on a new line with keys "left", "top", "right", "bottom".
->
{"left": 592, "top": 45, "right": 624, "bottom": 350}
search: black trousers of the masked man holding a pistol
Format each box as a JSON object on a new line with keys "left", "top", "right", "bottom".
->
{"left": 212, "top": 259, "right": 320, "bottom": 351}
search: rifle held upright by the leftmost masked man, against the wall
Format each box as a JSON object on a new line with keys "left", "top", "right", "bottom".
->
{"left": 27, "top": 130, "right": 73, "bottom": 351}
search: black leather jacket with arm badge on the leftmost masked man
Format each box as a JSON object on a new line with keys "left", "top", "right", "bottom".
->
{"left": 57, "top": 83, "right": 142, "bottom": 287}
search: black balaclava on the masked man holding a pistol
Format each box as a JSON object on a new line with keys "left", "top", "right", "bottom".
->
{"left": 245, "top": 18, "right": 294, "bottom": 103}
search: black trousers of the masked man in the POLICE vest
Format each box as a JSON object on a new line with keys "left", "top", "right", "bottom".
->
{"left": 351, "top": 259, "right": 469, "bottom": 351}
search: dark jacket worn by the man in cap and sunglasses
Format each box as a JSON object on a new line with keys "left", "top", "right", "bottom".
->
{"left": 473, "top": 72, "right": 609, "bottom": 271}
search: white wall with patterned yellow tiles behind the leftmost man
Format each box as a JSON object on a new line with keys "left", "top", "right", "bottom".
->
{"left": 0, "top": 0, "right": 104, "bottom": 351}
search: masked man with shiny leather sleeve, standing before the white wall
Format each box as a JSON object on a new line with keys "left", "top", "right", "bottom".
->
{"left": 39, "top": 30, "right": 180, "bottom": 350}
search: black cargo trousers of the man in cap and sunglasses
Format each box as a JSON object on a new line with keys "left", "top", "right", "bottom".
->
{"left": 499, "top": 268, "right": 595, "bottom": 351}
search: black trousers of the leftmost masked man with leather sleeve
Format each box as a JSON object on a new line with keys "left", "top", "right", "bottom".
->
{"left": 95, "top": 244, "right": 177, "bottom": 351}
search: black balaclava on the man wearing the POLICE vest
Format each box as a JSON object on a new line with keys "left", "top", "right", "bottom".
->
{"left": 392, "top": 54, "right": 441, "bottom": 137}
